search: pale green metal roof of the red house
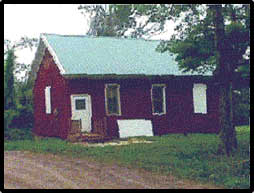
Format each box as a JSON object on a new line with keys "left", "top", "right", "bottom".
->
{"left": 43, "top": 34, "right": 210, "bottom": 75}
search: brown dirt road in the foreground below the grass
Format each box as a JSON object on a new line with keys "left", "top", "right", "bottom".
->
{"left": 4, "top": 151, "right": 219, "bottom": 189}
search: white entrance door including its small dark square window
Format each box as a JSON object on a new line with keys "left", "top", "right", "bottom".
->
{"left": 71, "top": 94, "right": 92, "bottom": 132}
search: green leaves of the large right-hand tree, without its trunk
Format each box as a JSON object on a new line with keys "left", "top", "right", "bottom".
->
{"left": 100, "top": 4, "right": 249, "bottom": 77}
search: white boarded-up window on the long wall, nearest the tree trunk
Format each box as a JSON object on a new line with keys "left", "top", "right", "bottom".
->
{"left": 193, "top": 84, "right": 207, "bottom": 114}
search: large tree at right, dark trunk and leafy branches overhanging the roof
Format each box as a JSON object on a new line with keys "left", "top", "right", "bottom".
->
{"left": 84, "top": 4, "right": 250, "bottom": 156}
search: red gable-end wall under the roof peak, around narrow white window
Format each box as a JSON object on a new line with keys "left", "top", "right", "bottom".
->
{"left": 33, "top": 50, "right": 70, "bottom": 138}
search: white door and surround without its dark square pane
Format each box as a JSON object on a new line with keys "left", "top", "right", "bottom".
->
{"left": 70, "top": 94, "right": 92, "bottom": 132}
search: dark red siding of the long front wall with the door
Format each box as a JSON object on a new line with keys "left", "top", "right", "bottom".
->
{"left": 69, "top": 77, "right": 218, "bottom": 137}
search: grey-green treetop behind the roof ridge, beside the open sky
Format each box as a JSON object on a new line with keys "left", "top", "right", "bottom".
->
{"left": 78, "top": 4, "right": 165, "bottom": 38}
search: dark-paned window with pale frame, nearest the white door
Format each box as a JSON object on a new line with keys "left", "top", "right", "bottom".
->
{"left": 105, "top": 84, "right": 121, "bottom": 115}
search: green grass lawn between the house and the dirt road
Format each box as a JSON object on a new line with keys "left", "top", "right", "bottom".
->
{"left": 4, "top": 126, "right": 250, "bottom": 188}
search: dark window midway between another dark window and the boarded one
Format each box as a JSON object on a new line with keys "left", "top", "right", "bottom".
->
{"left": 152, "top": 84, "right": 166, "bottom": 114}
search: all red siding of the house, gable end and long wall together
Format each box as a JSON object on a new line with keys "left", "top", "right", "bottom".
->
{"left": 33, "top": 50, "right": 219, "bottom": 138}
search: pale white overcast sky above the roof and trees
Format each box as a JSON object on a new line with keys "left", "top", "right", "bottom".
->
{"left": 4, "top": 4, "right": 173, "bottom": 64}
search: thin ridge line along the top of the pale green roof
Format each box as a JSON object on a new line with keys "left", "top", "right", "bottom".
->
{"left": 41, "top": 33, "right": 163, "bottom": 42}
